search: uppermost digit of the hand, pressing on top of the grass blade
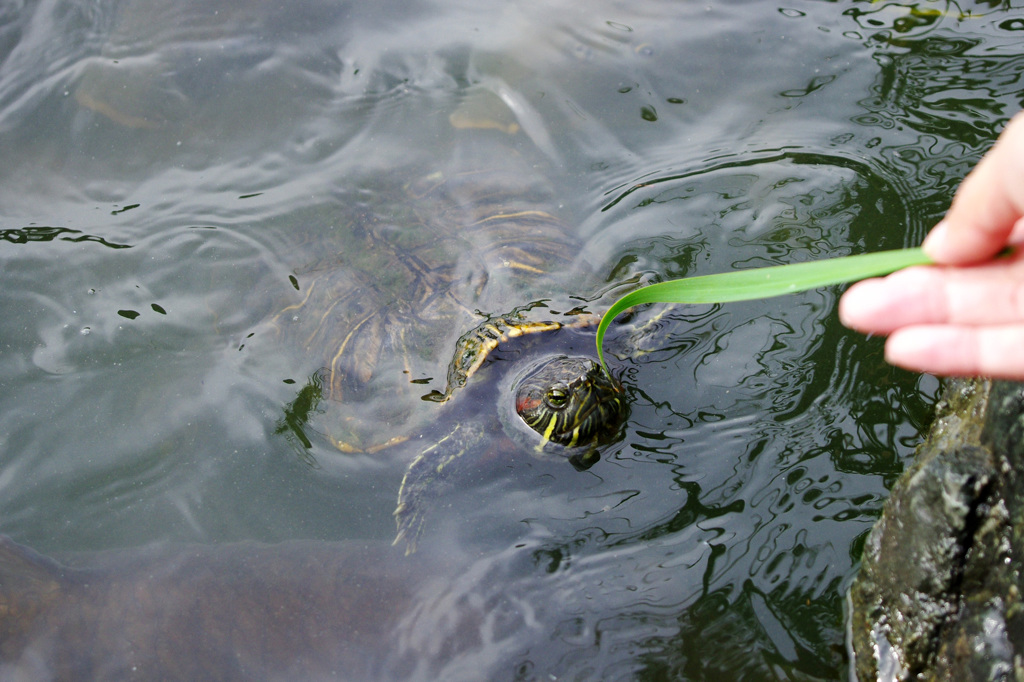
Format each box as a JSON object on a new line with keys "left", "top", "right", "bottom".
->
{"left": 924, "top": 114, "right": 1024, "bottom": 264}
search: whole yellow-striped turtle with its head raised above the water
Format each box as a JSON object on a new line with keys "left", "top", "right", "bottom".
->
{"left": 262, "top": 146, "right": 627, "bottom": 551}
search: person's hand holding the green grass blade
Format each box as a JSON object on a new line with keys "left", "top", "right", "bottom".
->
{"left": 839, "top": 114, "right": 1024, "bottom": 379}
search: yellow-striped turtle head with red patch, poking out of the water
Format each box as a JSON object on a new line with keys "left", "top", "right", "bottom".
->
{"left": 515, "top": 355, "right": 628, "bottom": 454}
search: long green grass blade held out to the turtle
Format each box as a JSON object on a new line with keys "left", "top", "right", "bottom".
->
{"left": 597, "top": 248, "right": 932, "bottom": 372}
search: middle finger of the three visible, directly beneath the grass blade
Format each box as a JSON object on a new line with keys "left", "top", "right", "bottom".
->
{"left": 840, "top": 255, "right": 1024, "bottom": 334}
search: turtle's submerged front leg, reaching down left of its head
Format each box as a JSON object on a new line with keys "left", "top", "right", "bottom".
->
{"left": 393, "top": 423, "right": 483, "bottom": 556}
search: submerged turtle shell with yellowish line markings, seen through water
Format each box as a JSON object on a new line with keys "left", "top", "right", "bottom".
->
{"left": 272, "top": 158, "right": 580, "bottom": 452}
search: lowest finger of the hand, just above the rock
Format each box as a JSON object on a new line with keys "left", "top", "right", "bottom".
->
{"left": 886, "top": 325, "right": 1024, "bottom": 379}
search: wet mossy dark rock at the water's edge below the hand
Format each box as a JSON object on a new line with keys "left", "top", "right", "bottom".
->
{"left": 849, "top": 380, "right": 1024, "bottom": 681}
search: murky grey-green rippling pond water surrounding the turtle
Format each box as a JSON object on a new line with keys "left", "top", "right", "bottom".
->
{"left": 0, "top": 0, "right": 1024, "bottom": 680}
